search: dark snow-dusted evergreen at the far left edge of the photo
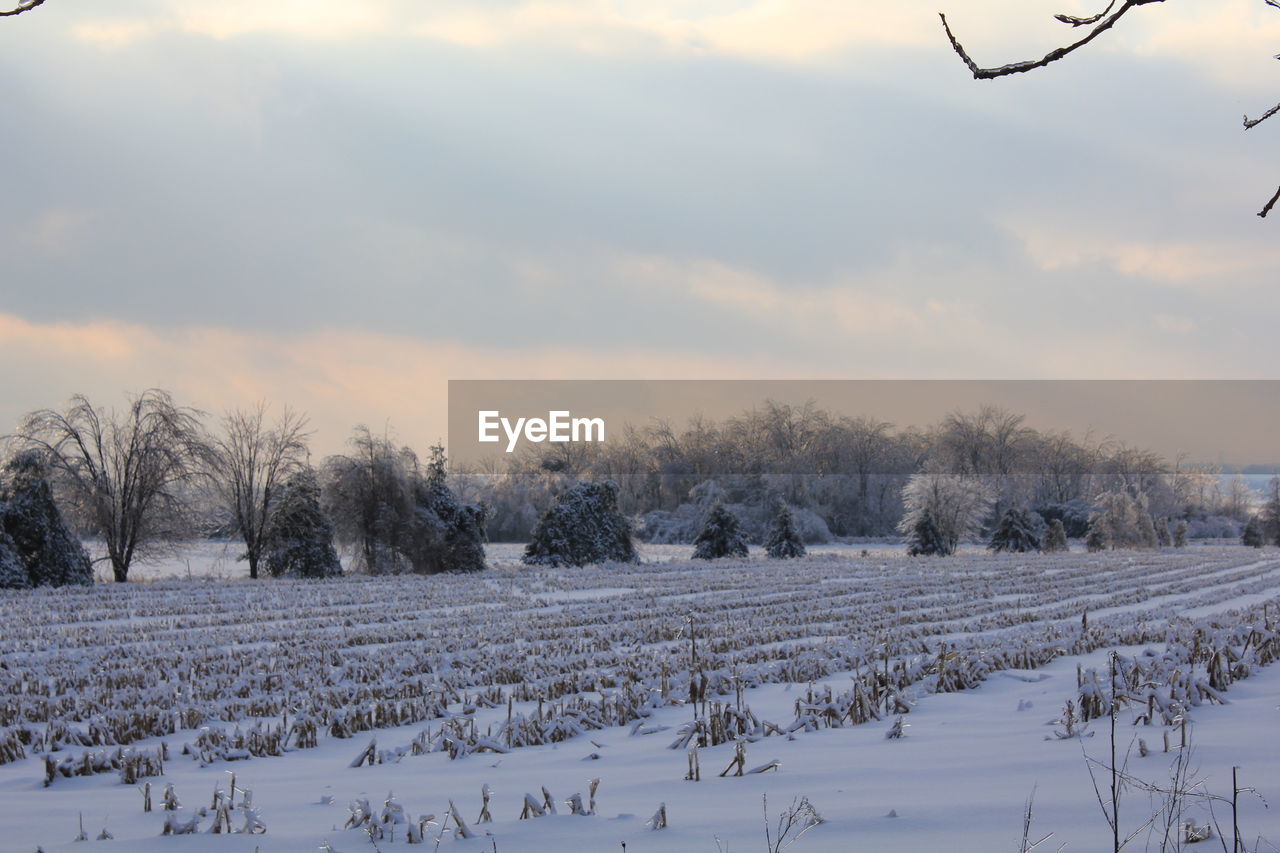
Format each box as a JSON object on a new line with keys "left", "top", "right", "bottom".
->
{"left": 0, "top": 451, "right": 93, "bottom": 587}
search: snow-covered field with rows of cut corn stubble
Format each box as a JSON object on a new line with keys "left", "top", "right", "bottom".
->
{"left": 0, "top": 546, "right": 1280, "bottom": 853}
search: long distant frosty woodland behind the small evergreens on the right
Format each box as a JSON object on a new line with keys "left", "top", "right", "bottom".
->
{"left": 454, "top": 401, "right": 1253, "bottom": 542}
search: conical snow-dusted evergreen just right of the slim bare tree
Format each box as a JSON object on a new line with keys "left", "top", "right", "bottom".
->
{"left": 262, "top": 467, "right": 342, "bottom": 578}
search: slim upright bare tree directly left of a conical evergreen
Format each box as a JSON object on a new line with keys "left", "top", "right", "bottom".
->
{"left": 210, "top": 402, "right": 310, "bottom": 578}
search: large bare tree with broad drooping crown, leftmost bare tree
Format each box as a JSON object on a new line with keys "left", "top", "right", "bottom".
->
{"left": 15, "top": 388, "right": 209, "bottom": 581}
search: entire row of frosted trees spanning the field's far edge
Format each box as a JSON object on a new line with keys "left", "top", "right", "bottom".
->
{"left": 0, "top": 389, "right": 1280, "bottom": 587}
